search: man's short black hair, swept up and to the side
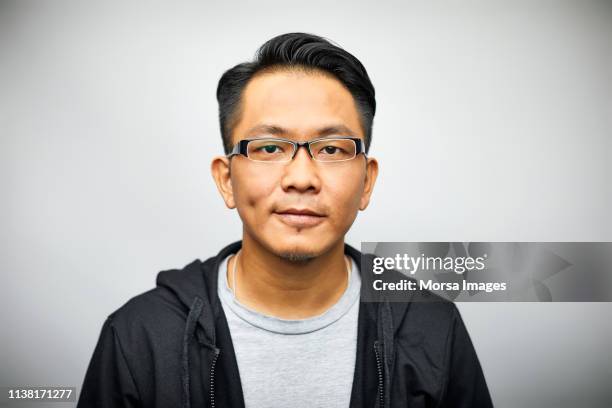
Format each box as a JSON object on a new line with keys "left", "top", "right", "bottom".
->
{"left": 217, "top": 33, "right": 376, "bottom": 154}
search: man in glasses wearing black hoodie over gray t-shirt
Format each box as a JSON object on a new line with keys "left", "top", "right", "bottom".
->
{"left": 78, "top": 33, "right": 492, "bottom": 408}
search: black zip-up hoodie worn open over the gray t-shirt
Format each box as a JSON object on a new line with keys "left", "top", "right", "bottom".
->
{"left": 77, "top": 241, "right": 492, "bottom": 408}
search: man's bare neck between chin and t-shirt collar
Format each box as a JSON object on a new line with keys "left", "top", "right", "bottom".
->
{"left": 227, "top": 232, "right": 347, "bottom": 319}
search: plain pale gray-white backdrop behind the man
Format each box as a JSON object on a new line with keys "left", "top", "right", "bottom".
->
{"left": 0, "top": 0, "right": 612, "bottom": 407}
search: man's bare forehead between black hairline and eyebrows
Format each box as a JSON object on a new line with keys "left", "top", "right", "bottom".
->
{"left": 233, "top": 70, "right": 363, "bottom": 142}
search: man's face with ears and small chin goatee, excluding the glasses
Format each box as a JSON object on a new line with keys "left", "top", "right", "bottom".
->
{"left": 212, "top": 70, "right": 377, "bottom": 259}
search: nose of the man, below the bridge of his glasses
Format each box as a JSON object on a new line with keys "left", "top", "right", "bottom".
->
{"left": 281, "top": 146, "right": 321, "bottom": 193}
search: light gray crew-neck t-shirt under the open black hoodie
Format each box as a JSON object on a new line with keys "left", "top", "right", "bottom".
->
{"left": 218, "top": 253, "right": 361, "bottom": 408}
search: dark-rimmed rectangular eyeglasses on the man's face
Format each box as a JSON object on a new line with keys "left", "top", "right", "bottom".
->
{"left": 227, "top": 137, "right": 367, "bottom": 163}
